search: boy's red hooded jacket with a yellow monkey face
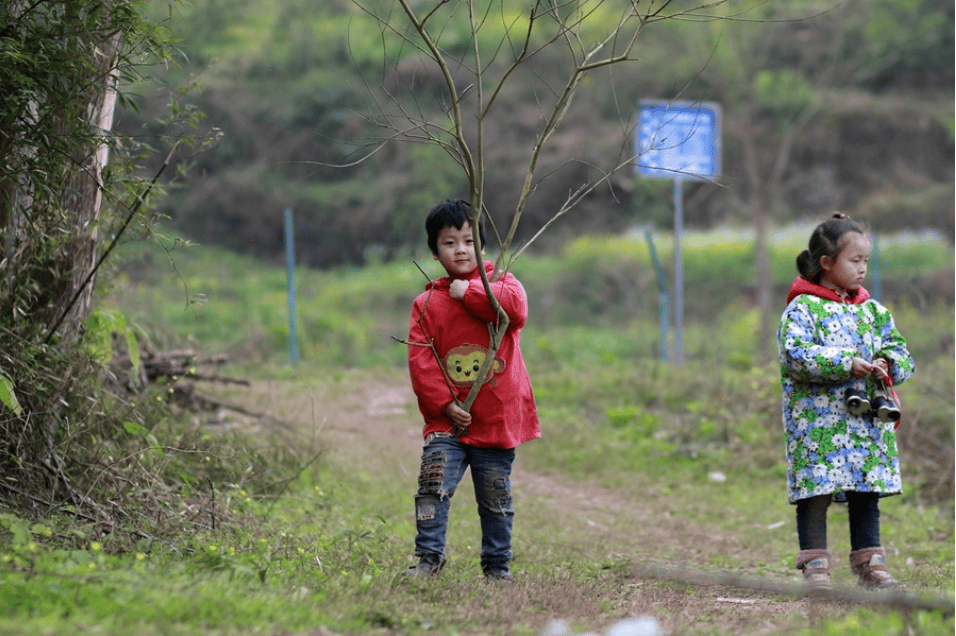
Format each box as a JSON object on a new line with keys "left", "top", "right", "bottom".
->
{"left": 408, "top": 261, "right": 541, "bottom": 448}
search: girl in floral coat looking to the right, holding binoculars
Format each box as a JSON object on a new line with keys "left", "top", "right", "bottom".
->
{"left": 777, "top": 213, "right": 914, "bottom": 591}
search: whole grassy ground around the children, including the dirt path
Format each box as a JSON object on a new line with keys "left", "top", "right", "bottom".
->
{"left": 0, "top": 230, "right": 956, "bottom": 636}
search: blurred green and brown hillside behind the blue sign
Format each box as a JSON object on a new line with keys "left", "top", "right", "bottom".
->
{"left": 119, "top": 0, "right": 954, "bottom": 267}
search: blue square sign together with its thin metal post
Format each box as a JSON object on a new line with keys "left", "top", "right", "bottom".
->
{"left": 634, "top": 100, "right": 720, "bottom": 364}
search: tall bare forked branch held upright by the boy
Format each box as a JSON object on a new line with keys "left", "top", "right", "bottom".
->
{"left": 352, "top": 0, "right": 740, "bottom": 410}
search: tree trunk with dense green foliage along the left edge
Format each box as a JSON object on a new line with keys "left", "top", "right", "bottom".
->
{"left": 0, "top": 0, "right": 230, "bottom": 548}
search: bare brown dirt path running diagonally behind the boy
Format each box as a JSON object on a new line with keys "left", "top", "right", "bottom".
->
{"left": 237, "top": 371, "right": 807, "bottom": 634}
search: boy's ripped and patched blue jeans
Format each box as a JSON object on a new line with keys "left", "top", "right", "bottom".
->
{"left": 415, "top": 433, "right": 515, "bottom": 567}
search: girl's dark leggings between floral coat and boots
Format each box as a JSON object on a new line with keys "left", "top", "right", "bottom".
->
{"left": 797, "top": 492, "right": 880, "bottom": 550}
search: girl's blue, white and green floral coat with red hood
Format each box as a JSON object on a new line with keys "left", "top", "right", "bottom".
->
{"left": 777, "top": 278, "right": 915, "bottom": 503}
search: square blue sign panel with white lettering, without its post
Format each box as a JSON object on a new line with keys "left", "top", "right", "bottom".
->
{"left": 634, "top": 100, "right": 720, "bottom": 181}
